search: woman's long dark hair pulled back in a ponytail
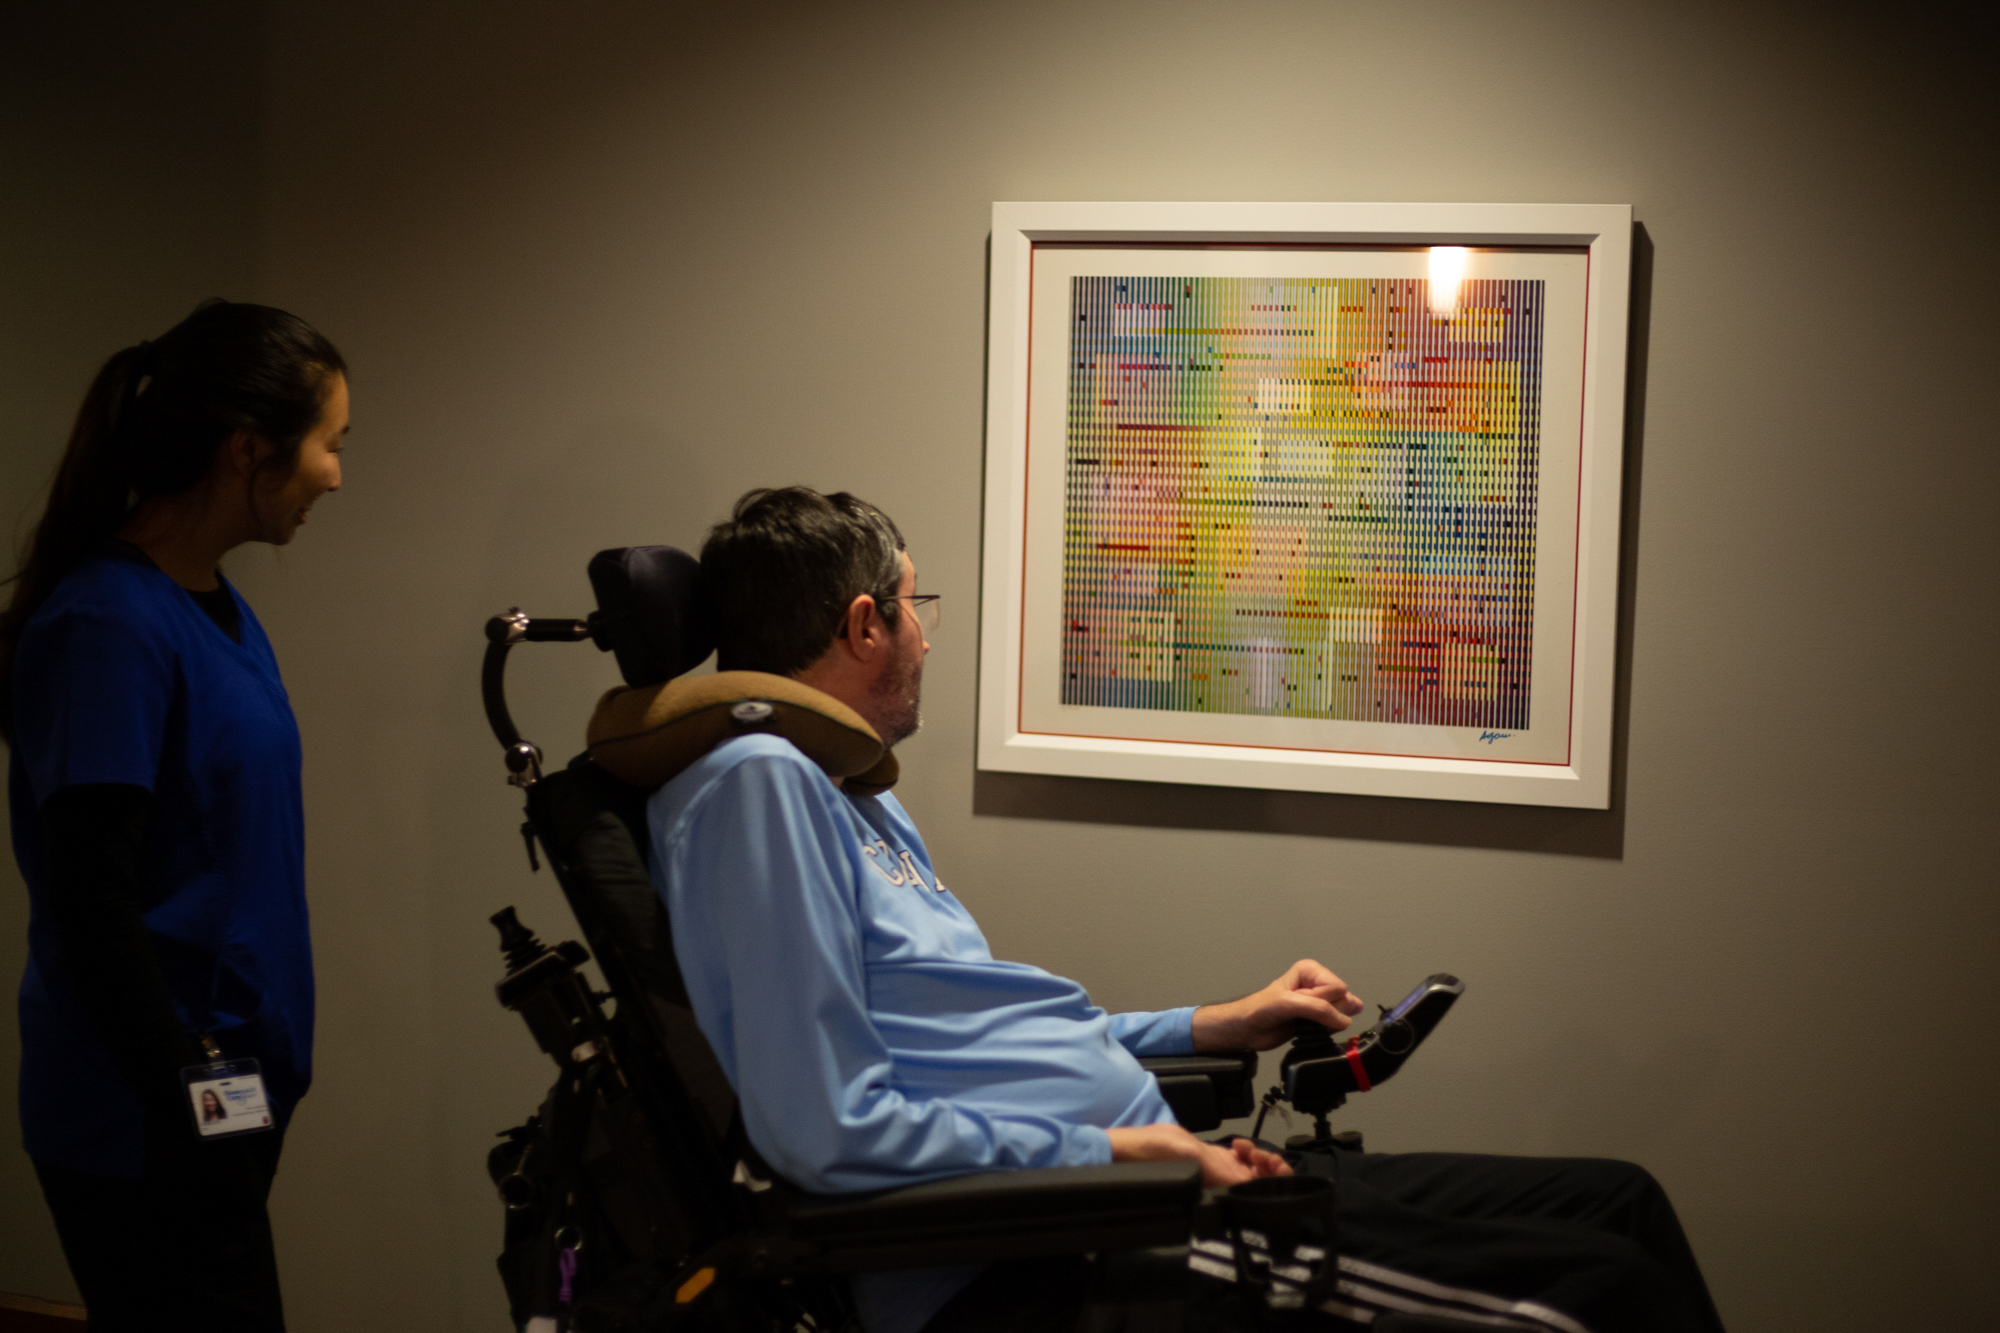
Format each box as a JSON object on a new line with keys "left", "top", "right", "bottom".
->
{"left": 0, "top": 300, "right": 346, "bottom": 741}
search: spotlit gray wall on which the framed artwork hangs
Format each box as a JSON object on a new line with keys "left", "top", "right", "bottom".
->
{"left": 0, "top": 0, "right": 2000, "bottom": 1333}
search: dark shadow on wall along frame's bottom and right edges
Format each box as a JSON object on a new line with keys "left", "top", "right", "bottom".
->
{"left": 972, "top": 222, "right": 1652, "bottom": 861}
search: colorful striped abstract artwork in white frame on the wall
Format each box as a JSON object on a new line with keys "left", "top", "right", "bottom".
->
{"left": 978, "top": 202, "right": 1632, "bottom": 809}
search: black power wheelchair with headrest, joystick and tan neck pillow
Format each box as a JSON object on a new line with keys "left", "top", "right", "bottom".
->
{"left": 482, "top": 546, "right": 1470, "bottom": 1333}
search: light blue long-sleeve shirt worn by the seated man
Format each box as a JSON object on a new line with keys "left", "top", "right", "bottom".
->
{"left": 648, "top": 735, "right": 1194, "bottom": 1333}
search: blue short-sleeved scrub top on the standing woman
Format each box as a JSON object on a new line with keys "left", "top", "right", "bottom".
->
{"left": 8, "top": 552, "right": 312, "bottom": 1179}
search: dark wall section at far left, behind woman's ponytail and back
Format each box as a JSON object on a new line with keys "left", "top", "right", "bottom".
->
{"left": 0, "top": 0, "right": 262, "bottom": 1299}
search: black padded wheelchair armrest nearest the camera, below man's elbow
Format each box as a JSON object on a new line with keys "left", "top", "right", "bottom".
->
{"left": 770, "top": 1161, "right": 1202, "bottom": 1273}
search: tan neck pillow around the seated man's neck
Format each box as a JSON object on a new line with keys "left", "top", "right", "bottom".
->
{"left": 584, "top": 671, "right": 898, "bottom": 797}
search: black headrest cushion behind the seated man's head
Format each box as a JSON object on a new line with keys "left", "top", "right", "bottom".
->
{"left": 590, "top": 546, "right": 716, "bottom": 687}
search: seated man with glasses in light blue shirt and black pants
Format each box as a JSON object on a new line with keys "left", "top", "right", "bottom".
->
{"left": 616, "top": 488, "right": 1720, "bottom": 1333}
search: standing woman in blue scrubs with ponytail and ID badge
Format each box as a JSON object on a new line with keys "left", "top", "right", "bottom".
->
{"left": 0, "top": 300, "right": 348, "bottom": 1333}
